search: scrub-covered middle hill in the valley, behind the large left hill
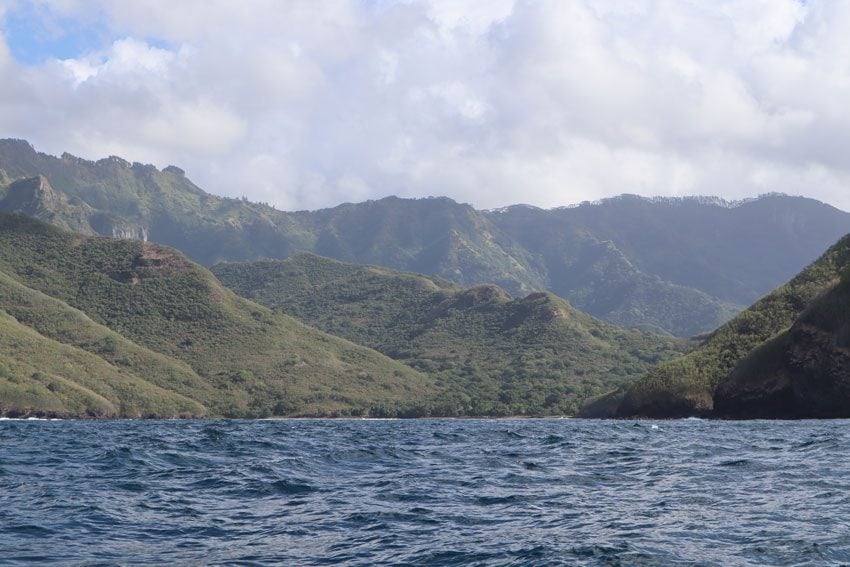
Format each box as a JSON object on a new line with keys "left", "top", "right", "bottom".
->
{"left": 211, "top": 254, "right": 686, "bottom": 415}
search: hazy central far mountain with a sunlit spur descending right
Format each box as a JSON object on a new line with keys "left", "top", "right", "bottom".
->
{"left": 293, "top": 197, "right": 546, "bottom": 295}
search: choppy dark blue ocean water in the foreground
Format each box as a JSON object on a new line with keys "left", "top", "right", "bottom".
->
{"left": 0, "top": 420, "right": 850, "bottom": 565}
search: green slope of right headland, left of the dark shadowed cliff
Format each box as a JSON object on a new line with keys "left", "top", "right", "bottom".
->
{"left": 617, "top": 236, "right": 850, "bottom": 417}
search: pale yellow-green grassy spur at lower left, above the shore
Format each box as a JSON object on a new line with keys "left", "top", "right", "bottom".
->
{"left": 0, "top": 272, "right": 210, "bottom": 417}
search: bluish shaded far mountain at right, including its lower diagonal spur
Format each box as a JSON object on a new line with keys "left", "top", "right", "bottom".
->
{"left": 488, "top": 195, "right": 850, "bottom": 328}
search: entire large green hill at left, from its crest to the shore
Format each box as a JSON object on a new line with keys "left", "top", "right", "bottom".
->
{"left": 0, "top": 214, "right": 438, "bottom": 417}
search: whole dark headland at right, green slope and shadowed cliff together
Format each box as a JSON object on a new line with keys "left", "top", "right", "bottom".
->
{"left": 604, "top": 260, "right": 850, "bottom": 419}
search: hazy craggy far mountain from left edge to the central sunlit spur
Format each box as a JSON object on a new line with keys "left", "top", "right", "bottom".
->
{"left": 0, "top": 140, "right": 544, "bottom": 292}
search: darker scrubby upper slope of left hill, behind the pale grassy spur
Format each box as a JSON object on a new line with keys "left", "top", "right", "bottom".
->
{"left": 0, "top": 215, "right": 433, "bottom": 416}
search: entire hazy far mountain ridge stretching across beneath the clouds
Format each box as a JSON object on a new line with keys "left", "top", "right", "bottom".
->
{"left": 0, "top": 140, "right": 850, "bottom": 336}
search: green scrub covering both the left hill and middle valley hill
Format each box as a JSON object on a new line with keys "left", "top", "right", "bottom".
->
{"left": 0, "top": 214, "right": 683, "bottom": 417}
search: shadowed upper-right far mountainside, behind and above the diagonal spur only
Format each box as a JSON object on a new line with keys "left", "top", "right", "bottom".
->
{"left": 553, "top": 194, "right": 850, "bottom": 305}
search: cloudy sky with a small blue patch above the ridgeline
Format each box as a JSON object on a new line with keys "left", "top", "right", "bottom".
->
{"left": 0, "top": 0, "right": 850, "bottom": 210}
